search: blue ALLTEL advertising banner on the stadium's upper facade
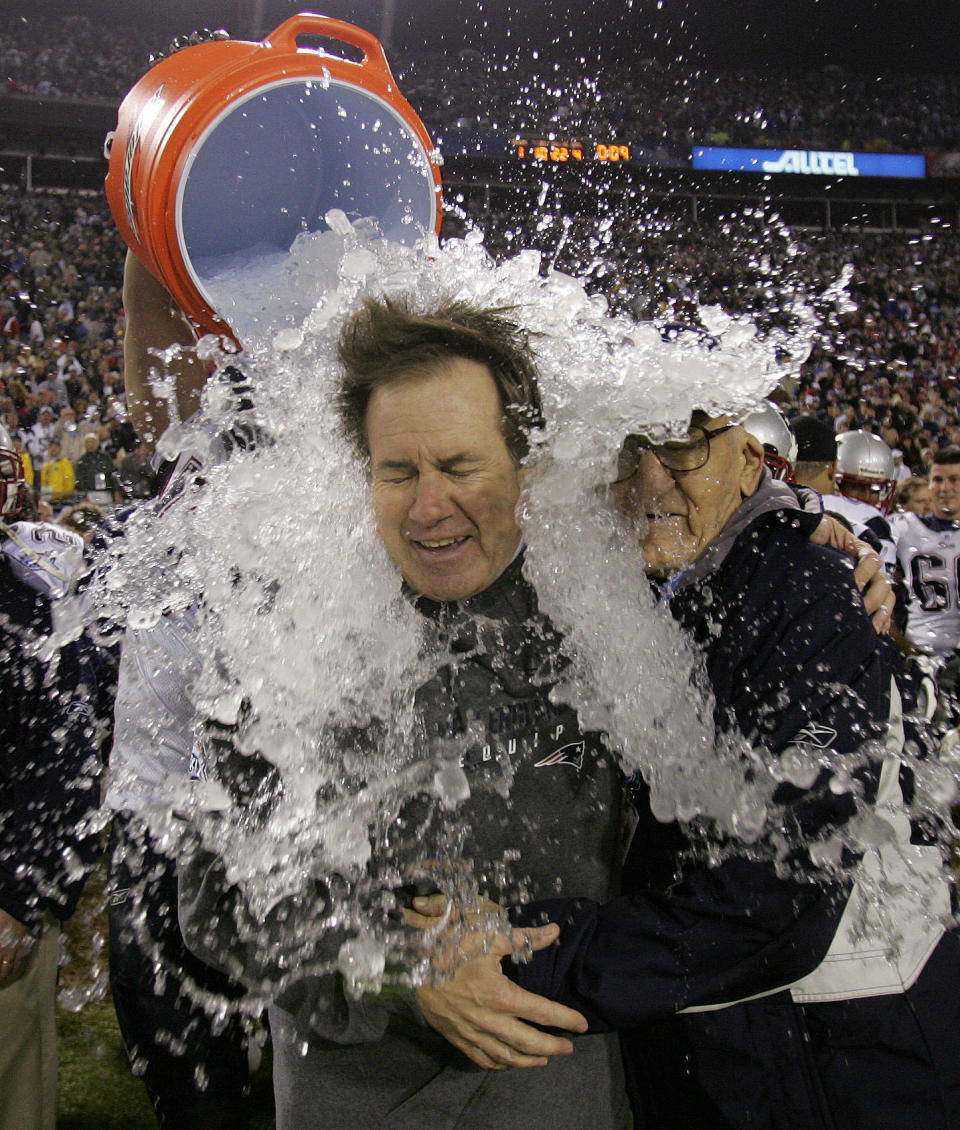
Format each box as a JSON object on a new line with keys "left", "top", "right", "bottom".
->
{"left": 692, "top": 146, "right": 926, "bottom": 177}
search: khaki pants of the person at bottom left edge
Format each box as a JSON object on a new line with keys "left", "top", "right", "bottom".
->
{"left": 0, "top": 916, "right": 60, "bottom": 1130}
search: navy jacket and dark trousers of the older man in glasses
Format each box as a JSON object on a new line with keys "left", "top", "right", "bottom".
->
{"left": 512, "top": 501, "right": 960, "bottom": 1130}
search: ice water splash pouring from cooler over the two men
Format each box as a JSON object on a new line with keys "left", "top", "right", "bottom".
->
{"left": 93, "top": 214, "right": 953, "bottom": 989}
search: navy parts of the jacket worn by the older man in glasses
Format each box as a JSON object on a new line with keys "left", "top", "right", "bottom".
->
{"left": 514, "top": 515, "right": 889, "bottom": 1029}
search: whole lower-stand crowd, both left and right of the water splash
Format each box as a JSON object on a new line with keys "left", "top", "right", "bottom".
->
{"left": 0, "top": 177, "right": 960, "bottom": 524}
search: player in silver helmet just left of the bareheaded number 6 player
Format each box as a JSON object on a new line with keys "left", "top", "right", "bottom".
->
{"left": 823, "top": 432, "right": 897, "bottom": 576}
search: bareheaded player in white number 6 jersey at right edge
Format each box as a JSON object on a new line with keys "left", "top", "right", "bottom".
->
{"left": 892, "top": 447, "right": 960, "bottom": 658}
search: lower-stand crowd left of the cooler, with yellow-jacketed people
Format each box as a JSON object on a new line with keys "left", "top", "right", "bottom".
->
{"left": 0, "top": 189, "right": 145, "bottom": 517}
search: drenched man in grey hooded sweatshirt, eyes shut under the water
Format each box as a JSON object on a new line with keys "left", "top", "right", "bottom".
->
{"left": 181, "top": 298, "right": 627, "bottom": 1130}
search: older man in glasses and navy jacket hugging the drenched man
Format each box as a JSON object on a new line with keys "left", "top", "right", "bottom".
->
{"left": 414, "top": 414, "right": 960, "bottom": 1130}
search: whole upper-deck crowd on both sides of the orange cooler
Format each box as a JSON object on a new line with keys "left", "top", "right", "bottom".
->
{"left": 0, "top": 15, "right": 960, "bottom": 155}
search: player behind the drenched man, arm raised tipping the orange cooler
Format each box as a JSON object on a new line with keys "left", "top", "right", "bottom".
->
{"left": 106, "top": 253, "right": 253, "bottom": 1130}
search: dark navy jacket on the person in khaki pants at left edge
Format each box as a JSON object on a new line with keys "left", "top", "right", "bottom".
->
{"left": 0, "top": 557, "right": 99, "bottom": 925}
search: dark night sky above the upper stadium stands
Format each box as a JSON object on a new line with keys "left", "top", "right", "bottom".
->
{"left": 13, "top": 0, "right": 960, "bottom": 73}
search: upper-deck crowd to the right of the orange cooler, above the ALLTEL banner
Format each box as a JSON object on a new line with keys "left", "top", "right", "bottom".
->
{"left": 399, "top": 53, "right": 958, "bottom": 153}
